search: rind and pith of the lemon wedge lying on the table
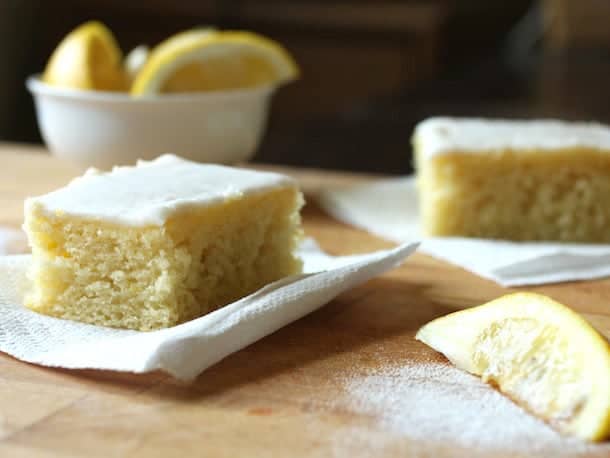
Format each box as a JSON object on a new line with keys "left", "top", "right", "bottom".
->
{"left": 416, "top": 292, "right": 610, "bottom": 441}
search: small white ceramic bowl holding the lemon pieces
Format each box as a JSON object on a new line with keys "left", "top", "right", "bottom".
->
{"left": 26, "top": 76, "right": 275, "bottom": 169}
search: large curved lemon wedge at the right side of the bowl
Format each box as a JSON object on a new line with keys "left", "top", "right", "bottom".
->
{"left": 131, "top": 30, "right": 299, "bottom": 96}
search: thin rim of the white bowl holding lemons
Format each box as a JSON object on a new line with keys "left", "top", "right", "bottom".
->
{"left": 25, "top": 73, "right": 278, "bottom": 104}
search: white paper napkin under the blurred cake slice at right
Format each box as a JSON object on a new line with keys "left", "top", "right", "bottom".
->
{"left": 318, "top": 177, "right": 610, "bottom": 286}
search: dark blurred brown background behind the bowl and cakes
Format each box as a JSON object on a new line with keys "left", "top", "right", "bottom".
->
{"left": 0, "top": 0, "right": 610, "bottom": 173}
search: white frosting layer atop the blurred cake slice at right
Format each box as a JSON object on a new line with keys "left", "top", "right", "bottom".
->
{"left": 414, "top": 117, "right": 610, "bottom": 159}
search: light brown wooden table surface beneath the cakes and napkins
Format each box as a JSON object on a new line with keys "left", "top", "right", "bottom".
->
{"left": 0, "top": 144, "right": 610, "bottom": 458}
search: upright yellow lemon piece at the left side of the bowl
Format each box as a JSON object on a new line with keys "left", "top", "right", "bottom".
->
{"left": 42, "top": 21, "right": 127, "bottom": 91}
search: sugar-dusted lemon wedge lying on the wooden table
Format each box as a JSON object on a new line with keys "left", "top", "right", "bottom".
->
{"left": 416, "top": 293, "right": 610, "bottom": 440}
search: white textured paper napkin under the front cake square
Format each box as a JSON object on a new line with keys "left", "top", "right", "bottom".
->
{"left": 0, "top": 240, "right": 417, "bottom": 380}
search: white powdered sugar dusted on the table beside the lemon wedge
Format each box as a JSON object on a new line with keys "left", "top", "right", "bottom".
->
{"left": 334, "top": 362, "right": 610, "bottom": 456}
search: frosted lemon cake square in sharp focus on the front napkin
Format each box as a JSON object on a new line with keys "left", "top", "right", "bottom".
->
{"left": 24, "top": 155, "right": 303, "bottom": 330}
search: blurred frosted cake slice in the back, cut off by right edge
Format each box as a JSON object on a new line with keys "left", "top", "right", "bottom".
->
{"left": 413, "top": 118, "right": 610, "bottom": 243}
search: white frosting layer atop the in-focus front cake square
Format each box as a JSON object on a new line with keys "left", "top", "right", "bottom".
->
{"left": 25, "top": 154, "right": 296, "bottom": 226}
